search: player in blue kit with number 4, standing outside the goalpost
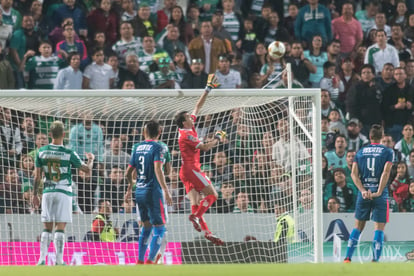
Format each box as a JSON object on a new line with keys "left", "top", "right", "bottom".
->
{"left": 344, "top": 125, "right": 394, "bottom": 263}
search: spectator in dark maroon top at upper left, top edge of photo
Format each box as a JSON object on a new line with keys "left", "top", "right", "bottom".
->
{"left": 86, "top": 0, "right": 119, "bottom": 45}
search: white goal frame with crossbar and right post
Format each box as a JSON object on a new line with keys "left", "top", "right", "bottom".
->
{"left": 0, "top": 88, "right": 323, "bottom": 263}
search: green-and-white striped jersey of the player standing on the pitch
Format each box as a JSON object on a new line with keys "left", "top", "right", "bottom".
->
{"left": 35, "top": 144, "right": 85, "bottom": 194}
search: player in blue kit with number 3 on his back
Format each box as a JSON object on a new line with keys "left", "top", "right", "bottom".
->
{"left": 125, "top": 120, "right": 172, "bottom": 264}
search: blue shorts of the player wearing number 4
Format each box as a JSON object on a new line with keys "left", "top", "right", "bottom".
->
{"left": 355, "top": 193, "right": 389, "bottom": 223}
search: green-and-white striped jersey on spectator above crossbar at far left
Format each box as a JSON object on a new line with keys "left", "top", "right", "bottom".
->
{"left": 25, "top": 55, "right": 63, "bottom": 89}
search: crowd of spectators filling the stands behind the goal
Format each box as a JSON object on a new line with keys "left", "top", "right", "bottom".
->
{"left": 0, "top": 0, "right": 414, "bottom": 213}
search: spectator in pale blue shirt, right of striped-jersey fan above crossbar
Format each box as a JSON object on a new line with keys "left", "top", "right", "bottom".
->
{"left": 53, "top": 52, "right": 82, "bottom": 90}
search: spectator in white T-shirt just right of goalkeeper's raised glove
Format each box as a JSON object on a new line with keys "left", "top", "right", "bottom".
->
{"left": 215, "top": 54, "right": 241, "bottom": 89}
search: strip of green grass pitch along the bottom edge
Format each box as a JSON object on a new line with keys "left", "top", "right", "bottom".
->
{"left": 0, "top": 263, "right": 414, "bottom": 276}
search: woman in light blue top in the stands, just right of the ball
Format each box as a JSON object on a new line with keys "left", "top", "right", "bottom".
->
{"left": 303, "top": 35, "right": 328, "bottom": 88}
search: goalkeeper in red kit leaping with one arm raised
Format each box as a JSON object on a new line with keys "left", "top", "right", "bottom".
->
{"left": 175, "top": 74, "right": 226, "bottom": 245}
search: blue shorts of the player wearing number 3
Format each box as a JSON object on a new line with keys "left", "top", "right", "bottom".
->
{"left": 135, "top": 189, "right": 167, "bottom": 225}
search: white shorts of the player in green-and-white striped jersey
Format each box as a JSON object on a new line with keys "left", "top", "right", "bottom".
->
{"left": 42, "top": 192, "right": 72, "bottom": 223}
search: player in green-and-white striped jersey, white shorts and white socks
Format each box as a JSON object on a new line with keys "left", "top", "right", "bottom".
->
{"left": 33, "top": 121, "right": 95, "bottom": 265}
